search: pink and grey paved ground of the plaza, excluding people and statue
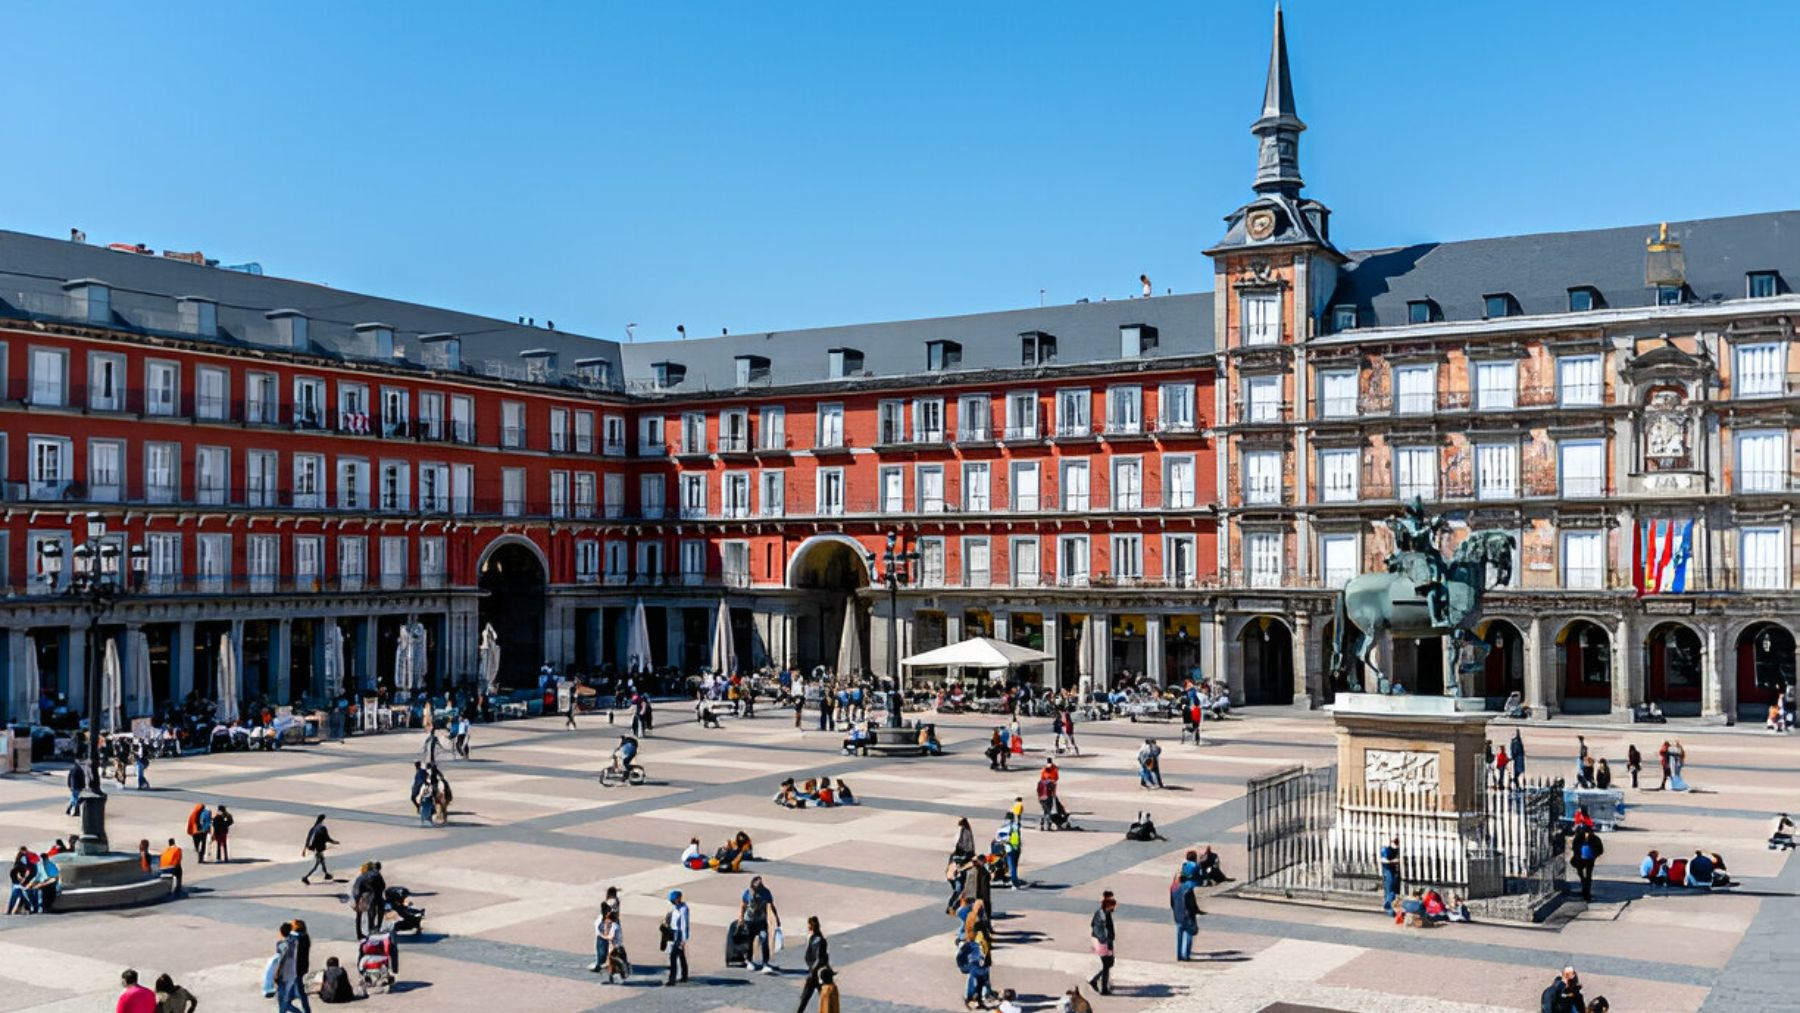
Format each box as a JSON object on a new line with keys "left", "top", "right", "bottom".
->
{"left": 0, "top": 705, "right": 1800, "bottom": 1013}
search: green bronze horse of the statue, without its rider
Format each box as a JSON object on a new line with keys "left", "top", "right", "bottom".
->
{"left": 1332, "top": 531, "right": 1516, "bottom": 695}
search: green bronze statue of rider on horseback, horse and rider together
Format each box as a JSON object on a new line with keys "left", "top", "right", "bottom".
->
{"left": 1332, "top": 498, "right": 1516, "bottom": 696}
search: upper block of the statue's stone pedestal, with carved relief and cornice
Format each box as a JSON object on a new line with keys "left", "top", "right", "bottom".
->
{"left": 1332, "top": 693, "right": 1499, "bottom": 811}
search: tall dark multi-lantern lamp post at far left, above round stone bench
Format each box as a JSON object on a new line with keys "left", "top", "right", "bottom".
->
{"left": 38, "top": 513, "right": 149, "bottom": 855}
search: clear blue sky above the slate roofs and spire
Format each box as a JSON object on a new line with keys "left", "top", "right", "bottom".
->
{"left": 0, "top": 0, "right": 1800, "bottom": 338}
